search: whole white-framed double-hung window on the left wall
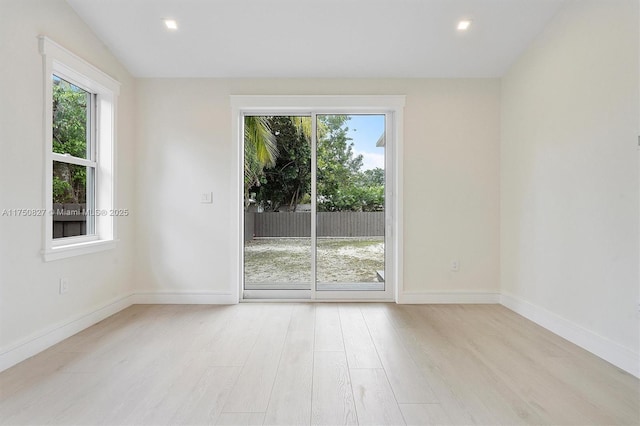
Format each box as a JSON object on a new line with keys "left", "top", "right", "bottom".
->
{"left": 40, "top": 37, "right": 119, "bottom": 261}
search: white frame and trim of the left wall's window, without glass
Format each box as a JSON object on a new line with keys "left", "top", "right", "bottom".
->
{"left": 38, "top": 36, "right": 120, "bottom": 261}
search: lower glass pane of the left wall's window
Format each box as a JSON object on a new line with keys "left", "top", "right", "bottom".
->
{"left": 52, "top": 161, "right": 95, "bottom": 238}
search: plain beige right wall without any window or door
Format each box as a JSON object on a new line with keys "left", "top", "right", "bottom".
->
{"left": 501, "top": 0, "right": 640, "bottom": 374}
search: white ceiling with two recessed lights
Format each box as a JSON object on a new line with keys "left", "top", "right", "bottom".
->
{"left": 67, "top": 0, "right": 565, "bottom": 78}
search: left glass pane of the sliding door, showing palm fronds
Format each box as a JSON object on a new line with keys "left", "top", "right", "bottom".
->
{"left": 244, "top": 116, "right": 312, "bottom": 290}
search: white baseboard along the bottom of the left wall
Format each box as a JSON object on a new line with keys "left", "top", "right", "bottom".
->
{"left": 0, "top": 295, "right": 133, "bottom": 371}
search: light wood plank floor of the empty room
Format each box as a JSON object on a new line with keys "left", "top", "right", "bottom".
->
{"left": 0, "top": 303, "right": 640, "bottom": 425}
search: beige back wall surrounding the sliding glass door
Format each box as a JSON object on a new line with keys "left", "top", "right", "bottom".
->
{"left": 136, "top": 79, "right": 500, "bottom": 294}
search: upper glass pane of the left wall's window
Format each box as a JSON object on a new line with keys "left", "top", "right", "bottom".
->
{"left": 53, "top": 75, "right": 91, "bottom": 158}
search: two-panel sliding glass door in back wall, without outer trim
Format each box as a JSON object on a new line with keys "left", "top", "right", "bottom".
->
{"left": 243, "top": 113, "right": 388, "bottom": 299}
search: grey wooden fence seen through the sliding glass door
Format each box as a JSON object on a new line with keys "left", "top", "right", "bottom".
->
{"left": 244, "top": 212, "right": 384, "bottom": 240}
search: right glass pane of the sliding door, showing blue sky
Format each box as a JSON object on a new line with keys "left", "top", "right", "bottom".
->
{"left": 316, "top": 114, "right": 385, "bottom": 290}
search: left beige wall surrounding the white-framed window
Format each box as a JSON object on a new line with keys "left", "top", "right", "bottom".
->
{"left": 0, "top": 0, "right": 136, "bottom": 355}
